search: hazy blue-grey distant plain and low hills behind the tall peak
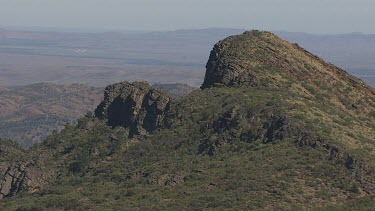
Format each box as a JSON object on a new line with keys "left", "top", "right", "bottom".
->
{"left": 0, "top": 28, "right": 375, "bottom": 87}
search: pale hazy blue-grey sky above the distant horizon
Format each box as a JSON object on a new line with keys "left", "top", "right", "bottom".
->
{"left": 0, "top": 0, "right": 375, "bottom": 34}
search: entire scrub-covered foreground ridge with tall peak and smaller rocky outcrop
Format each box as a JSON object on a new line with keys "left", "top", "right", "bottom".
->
{"left": 0, "top": 31, "right": 375, "bottom": 210}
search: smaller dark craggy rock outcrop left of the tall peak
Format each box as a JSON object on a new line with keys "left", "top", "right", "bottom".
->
{"left": 95, "top": 82, "right": 171, "bottom": 136}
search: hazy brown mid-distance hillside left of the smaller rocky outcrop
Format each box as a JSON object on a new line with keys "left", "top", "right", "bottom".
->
{"left": 0, "top": 83, "right": 102, "bottom": 147}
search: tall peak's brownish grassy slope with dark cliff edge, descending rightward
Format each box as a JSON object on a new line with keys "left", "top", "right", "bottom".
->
{"left": 202, "top": 31, "right": 375, "bottom": 157}
